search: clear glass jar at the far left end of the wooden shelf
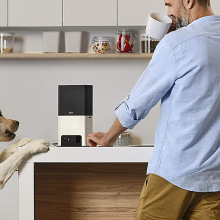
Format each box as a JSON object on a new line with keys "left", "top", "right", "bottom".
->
{"left": 0, "top": 33, "right": 14, "bottom": 53}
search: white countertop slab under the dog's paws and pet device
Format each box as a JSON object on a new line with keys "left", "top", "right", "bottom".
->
{"left": 24, "top": 145, "right": 154, "bottom": 163}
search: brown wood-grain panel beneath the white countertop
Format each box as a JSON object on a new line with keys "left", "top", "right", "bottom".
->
{"left": 35, "top": 163, "right": 147, "bottom": 220}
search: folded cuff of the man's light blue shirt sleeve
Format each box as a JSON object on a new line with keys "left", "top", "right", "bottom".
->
{"left": 115, "top": 97, "right": 140, "bottom": 129}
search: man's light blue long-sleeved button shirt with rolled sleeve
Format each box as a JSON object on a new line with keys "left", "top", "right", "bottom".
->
{"left": 115, "top": 16, "right": 220, "bottom": 192}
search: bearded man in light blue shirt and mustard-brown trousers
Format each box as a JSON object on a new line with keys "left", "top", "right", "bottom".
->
{"left": 87, "top": 0, "right": 220, "bottom": 220}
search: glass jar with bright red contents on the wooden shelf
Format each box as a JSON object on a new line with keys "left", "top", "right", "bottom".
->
{"left": 116, "top": 30, "right": 135, "bottom": 53}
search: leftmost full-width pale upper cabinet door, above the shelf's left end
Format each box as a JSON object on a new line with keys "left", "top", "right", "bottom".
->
{"left": 8, "top": 0, "right": 62, "bottom": 26}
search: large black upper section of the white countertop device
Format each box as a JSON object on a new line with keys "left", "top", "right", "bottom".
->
{"left": 58, "top": 85, "right": 93, "bottom": 116}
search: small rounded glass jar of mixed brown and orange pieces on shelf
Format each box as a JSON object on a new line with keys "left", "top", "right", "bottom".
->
{"left": 92, "top": 36, "right": 111, "bottom": 53}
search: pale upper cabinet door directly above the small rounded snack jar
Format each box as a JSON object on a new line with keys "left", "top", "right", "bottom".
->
{"left": 63, "top": 0, "right": 117, "bottom": 26}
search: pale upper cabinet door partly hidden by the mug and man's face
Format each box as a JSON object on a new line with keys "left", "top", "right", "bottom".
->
{"left": 118, "top": 0, "right": 167, "bottom": 26}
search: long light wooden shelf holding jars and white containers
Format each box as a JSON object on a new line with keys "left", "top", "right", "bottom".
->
{"left": 0, "top": 53, "right": 152, "bottom": 60}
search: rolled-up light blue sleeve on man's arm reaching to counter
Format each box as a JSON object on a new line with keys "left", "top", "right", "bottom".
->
{"left": 115, "top": 39, "right": 179, "bottom": 129}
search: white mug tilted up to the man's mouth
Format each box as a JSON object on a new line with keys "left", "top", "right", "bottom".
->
{"left": 146, "top": 13, "right": 172, "bottom": 40}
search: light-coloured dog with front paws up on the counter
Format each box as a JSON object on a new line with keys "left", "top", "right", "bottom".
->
{"left": 0, "top": 110, "right": 50, "bottom": 189}
